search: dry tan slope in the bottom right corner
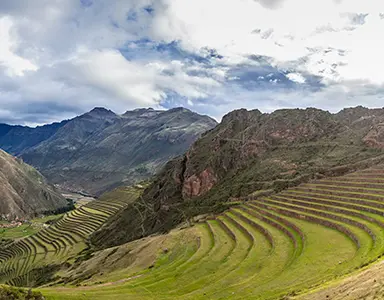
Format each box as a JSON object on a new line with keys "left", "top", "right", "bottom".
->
{"left": 295, "top": 260, "right": 384, "bottom": 300}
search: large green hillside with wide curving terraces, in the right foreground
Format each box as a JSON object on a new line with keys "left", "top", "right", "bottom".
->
{"left": 42, "top": 168, "right": 384, "bottom": 299}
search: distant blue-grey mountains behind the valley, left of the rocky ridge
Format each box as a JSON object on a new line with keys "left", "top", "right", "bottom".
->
{"left": 0, "top": 107, "right": 217, "bottom": 195}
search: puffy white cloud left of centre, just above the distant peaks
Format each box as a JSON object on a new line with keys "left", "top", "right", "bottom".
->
{"left": 73, "top": 50, "right": 220, "bottom": 106}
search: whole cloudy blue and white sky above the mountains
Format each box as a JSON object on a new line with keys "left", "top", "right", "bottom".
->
{"left": 0, "top": 0, "right": 384, "bottom": 126}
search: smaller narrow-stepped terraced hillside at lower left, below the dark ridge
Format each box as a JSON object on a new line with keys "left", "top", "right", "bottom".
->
{"left": 0, "top": 189, "right": 138, "bottom": 286}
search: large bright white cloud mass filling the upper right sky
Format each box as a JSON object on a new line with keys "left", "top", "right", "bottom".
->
{"left": 153, "top": 0, "right": 384, "bottom": 83}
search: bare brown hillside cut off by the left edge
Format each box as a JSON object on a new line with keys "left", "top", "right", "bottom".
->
{"left": 0, "top": 150, "right": 68, "bottom": 220}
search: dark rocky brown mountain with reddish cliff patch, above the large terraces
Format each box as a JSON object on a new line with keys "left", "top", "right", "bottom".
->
{"left": 93, "top": 107, "right": 384, "bottom": 247}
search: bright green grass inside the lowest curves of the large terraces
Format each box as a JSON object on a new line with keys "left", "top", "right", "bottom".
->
{"left": 36, "top": 212, "right": 356, "bottom": 299}
